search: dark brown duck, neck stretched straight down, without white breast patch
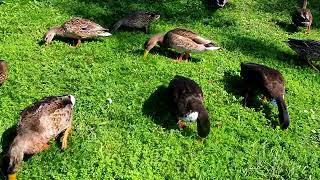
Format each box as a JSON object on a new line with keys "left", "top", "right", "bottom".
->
{"left": 240, "top": 63, "right": 289, "bottom": 129}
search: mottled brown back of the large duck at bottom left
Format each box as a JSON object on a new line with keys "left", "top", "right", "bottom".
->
{"left": 17, "top": 96, "right": 72, "bottom": 139}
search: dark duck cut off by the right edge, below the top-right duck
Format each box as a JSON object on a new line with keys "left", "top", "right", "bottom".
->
{"left": 285, "top": 38, "right": 320, "bottom": 71}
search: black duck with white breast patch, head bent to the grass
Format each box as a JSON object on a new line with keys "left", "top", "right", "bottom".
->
{"left": 168, "top": 75, "right": 210, "bottom": 138}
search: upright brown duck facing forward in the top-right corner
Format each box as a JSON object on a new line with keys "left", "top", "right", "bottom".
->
{"left": 292, "top": 0, "right": 313, "bottom": 33}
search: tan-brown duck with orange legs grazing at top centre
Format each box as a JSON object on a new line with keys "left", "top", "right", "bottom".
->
{"left": 144, "top": 28, "right": 220, "bottom": 61}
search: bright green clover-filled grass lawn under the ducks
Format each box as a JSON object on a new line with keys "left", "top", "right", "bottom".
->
{"left": 0, "top": 0, "right": 320, "bottom": 179}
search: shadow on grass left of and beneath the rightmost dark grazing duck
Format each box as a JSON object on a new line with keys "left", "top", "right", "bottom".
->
{"left": 222, "top": 71, "right": 279, "bottom": 128}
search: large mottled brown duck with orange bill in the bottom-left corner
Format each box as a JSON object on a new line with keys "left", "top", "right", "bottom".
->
{"left": 7, "top": 95, "right": 75, "bottom": 180}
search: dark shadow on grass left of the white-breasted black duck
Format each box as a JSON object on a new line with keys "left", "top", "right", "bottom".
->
{"left": 143, "top": 85, "right": 178, "bottom": 129}
